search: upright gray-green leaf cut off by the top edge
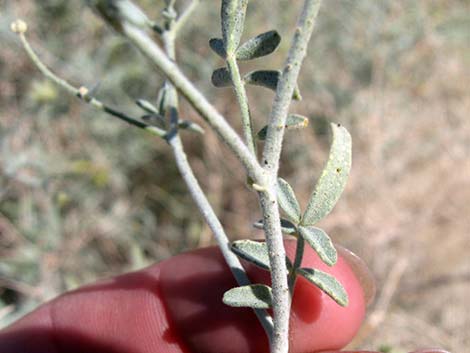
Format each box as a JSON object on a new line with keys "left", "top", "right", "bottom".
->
{"left": 220, "top": 0, "right": 248, "bottom": 55}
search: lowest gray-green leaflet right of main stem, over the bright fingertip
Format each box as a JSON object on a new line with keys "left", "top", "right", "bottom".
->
{"left": 296, "top": 268, "right": 349, "bottom": 306}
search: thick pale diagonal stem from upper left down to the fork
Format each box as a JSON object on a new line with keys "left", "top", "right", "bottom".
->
{"left": 123, "top": 24, "right": 265, "bottom": 184}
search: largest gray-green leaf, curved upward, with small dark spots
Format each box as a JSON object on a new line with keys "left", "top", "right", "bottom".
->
{"left": 302, "top": 124, "right": 352, "bottom": 226}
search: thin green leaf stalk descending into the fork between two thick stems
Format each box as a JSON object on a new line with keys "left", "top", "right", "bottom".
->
{"left": 227, "top": 55, "right": 256, "bottom": 156}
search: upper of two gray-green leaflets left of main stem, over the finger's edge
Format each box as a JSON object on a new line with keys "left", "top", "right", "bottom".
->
{"left": 231, "top": 239, "right": 292, "bottom": 270}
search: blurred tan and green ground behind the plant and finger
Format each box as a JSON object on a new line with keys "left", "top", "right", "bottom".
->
{"left": 0, "top": 0, "right": 470, "bottom": 353}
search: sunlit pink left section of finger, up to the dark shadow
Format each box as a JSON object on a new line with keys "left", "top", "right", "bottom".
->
{"left": 0, "top": 265, "right": 189, "bottom": 353}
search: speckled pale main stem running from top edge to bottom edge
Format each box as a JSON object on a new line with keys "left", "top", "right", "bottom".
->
{"left": 260, "top": 0, "right": 321, "bottom": 353}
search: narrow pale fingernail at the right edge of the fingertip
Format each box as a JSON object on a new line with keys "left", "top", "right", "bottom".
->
{"left": 335, "top": 244, "right": 376, "bottom": 306}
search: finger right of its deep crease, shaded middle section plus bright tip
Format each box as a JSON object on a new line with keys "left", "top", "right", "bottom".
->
{"left": 160, "top": 241, "right": 365, "bottom": 353}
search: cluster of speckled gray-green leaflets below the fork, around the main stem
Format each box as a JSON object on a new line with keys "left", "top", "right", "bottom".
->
{"left": 223, "top": 124, "right": 352, "bottom": 308}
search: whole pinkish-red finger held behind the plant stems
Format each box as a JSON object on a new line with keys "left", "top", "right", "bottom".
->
{"left": 0, "top": 241, "right": 365, "bottom": 353}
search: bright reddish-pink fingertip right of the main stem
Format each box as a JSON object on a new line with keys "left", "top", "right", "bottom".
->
{"left": 253, "top": 240, "right": 365, "bottom": 353}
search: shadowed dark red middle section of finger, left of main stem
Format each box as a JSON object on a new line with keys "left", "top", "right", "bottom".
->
{"left": 160, "top": 247, "right": 269, "bottom": 353}
